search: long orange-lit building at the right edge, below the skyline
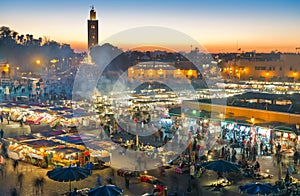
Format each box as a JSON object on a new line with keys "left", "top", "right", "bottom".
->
{"left": 222, "top": 54, "right": 300, "bottom": 82}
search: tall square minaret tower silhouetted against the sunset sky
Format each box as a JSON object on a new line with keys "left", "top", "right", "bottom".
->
{"left": 88, "top": 6, "right": 98, "bottom": 61}
